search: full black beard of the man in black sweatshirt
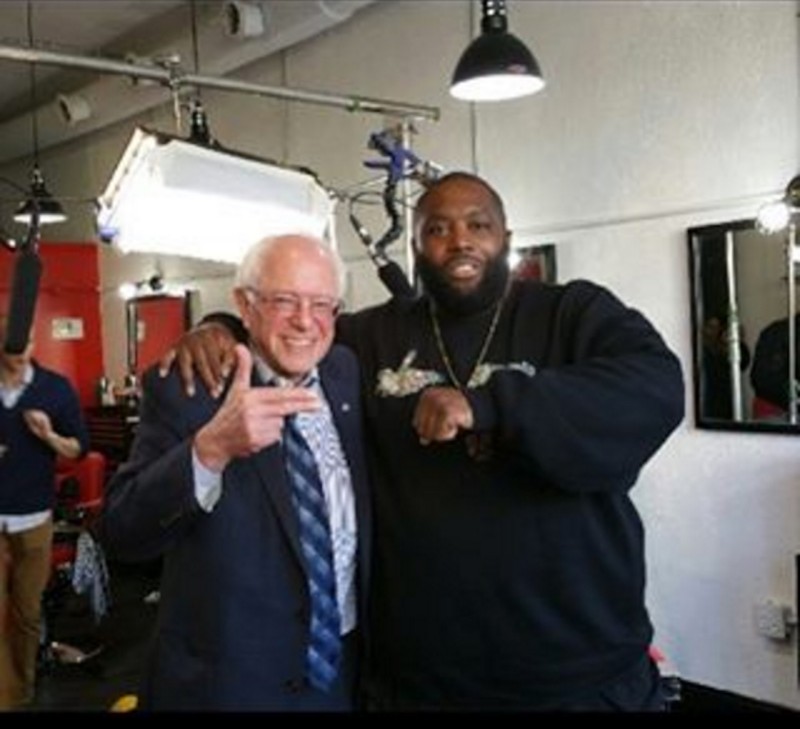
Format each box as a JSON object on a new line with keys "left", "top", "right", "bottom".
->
{"left": 416, "top": 248, "right": 509, "bottom": 316}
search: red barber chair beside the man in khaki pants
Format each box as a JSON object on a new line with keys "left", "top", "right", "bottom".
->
{"left": 39, "top": 451, "right": 108, "bottom": 669}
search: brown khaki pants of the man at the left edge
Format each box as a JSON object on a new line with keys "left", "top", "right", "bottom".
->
{"left": 0, "top": 519, "right": 53, "bottom": 710}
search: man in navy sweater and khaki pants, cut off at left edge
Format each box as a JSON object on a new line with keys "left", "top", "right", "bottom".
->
{"left": 0, "top": 315, "right": 89, "bottom": 710}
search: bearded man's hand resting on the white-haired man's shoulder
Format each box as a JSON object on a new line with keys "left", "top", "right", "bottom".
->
{"left": 158, "top": 322, "right": 236, "bottom": 397}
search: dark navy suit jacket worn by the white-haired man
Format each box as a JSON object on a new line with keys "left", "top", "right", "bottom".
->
{"left": 97, "top": 346, "right": 370, "bottom": 711}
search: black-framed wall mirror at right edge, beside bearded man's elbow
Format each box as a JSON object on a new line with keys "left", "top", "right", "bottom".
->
{"left": 688, "top": 219, "right": 800, "bottom": 433}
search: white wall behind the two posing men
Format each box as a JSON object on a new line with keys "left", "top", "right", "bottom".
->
{"left": 9, "top": 0, "right": 800, "bottom": 708}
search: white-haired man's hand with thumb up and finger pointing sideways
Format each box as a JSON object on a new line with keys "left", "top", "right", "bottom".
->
{"left": 194, "top": 344, "right": 321, "bottom": 473}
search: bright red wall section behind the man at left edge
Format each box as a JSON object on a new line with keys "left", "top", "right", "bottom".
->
{"left": 0, "top": 242, "right": 103, "bottom": 407}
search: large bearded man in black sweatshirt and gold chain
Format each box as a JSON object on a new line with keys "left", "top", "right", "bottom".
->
{"left": 164, "top": 172, "right": 684, "bottom": 711}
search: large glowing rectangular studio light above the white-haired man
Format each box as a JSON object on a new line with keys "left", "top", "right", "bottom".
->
{"left": 97, "top": 127, "right": 334, "bottom": 263}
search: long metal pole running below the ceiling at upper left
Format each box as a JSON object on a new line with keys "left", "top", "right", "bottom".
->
{"left": 0, "top": 44, "right": 440, "bottom": 121}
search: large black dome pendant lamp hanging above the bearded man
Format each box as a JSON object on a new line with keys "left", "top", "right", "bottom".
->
{"left": 450, "top": 0, "right": 545, "bottom": 101}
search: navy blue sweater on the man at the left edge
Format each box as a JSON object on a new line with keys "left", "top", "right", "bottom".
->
{"left": 0, "top": 363, "right": 89, "bottom": 514}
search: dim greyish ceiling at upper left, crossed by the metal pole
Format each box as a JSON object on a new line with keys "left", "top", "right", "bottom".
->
{"left": 0, "top": 0, "right": 375, "bottom": 164}
